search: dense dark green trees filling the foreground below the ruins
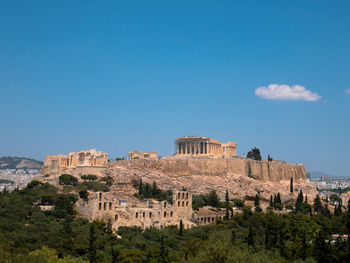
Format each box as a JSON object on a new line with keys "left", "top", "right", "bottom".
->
{"left": 0, "top": 181, "right": 350, "bottom": 263}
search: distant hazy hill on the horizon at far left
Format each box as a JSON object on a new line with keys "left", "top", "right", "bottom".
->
{"left": 0, "top": 156, "right": 43, "bottom": 169}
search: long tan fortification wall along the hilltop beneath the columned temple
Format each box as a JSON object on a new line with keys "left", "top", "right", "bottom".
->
{"left": 126, "top": 157, "right": 306, "bottom": 181}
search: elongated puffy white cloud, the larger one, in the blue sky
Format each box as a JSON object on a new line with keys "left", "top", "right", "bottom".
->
{"left": 255, "top": 84, "right": 321, "bottom": 101}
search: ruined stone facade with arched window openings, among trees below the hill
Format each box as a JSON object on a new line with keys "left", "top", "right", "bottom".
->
{"left": 77, "top": 189, "right": 196, "bottom": 230}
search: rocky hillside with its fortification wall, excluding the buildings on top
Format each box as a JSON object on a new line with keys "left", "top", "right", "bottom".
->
{"left": 101, "top": 157, "right": 317, "bottom": 206}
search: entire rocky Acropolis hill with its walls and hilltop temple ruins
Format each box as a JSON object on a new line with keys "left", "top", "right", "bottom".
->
{"left": 42, "top": 136, "right": 317, "bottom": 207}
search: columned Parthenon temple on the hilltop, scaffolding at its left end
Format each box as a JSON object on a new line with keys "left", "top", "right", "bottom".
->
{"left": 176, "top": 136, "right": 237, "bottom": 156}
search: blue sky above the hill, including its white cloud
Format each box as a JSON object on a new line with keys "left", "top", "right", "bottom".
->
{"left": 0, "top": 0, "right": 350, "bottom": 176}
